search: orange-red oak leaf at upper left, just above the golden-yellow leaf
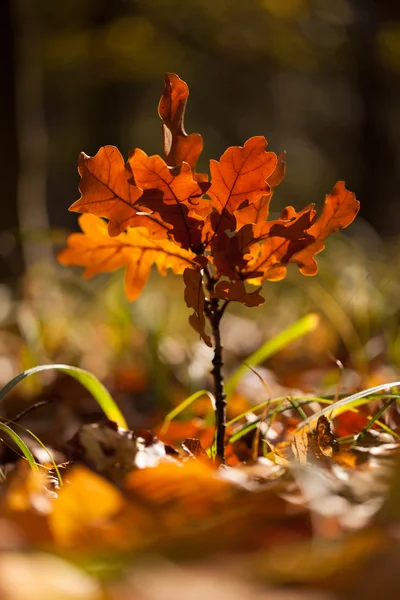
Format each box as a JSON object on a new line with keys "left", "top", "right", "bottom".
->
{"left": 69, "top": 146, "right": 166, "bottom": 236}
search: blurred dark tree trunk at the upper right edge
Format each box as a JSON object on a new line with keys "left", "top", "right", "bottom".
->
{"left": 352, "top": 0, "right": 400, "bottom": 235}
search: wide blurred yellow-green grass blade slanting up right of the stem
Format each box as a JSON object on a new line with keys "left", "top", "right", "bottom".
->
{"left": 225, "top": 313, "right": 319, "bottom": 397}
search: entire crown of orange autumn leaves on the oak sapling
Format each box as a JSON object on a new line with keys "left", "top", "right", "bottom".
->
{"left": 60, "top": 73, "right": 359, "bottom": 372}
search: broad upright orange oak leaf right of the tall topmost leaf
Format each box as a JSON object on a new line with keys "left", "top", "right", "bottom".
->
{"left": 208, "top": 136, "right": 278, "bottom": 234}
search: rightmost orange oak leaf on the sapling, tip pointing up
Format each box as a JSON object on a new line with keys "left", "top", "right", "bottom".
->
{"left": 293, "top": 181, "right": 360, "bottom": 275}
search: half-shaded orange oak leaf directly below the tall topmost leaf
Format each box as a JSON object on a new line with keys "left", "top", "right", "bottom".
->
{"left": 128, "top": 148, "right": 212, "bottom": 249}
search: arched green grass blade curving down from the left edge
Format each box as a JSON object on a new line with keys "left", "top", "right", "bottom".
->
{"left": 0, "top": 365, "right": 128, "bottom": 429}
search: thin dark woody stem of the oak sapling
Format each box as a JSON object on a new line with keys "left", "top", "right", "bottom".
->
{"left": 204, "top": 269, "right": 229, "bottom": 464}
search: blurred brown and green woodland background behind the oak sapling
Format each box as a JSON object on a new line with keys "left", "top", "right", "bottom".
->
{"left": 0, "top": 0, "right": 400, "bottom": 432}
